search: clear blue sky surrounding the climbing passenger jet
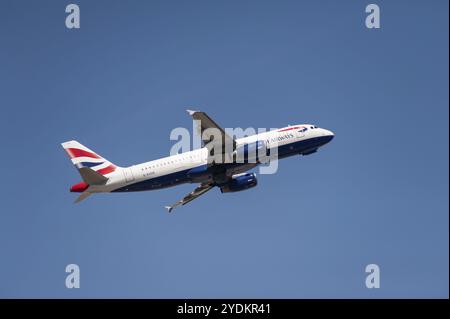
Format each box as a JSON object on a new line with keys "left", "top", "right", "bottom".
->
{"left": 0, "top": 0, "right": 449, "bottom": 298}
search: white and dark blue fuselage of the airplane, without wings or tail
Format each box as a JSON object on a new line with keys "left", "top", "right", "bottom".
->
{"left": 89, "top": 124, "right": 333, "bottom": 193}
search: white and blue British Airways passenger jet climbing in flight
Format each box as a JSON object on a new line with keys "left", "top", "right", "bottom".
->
{"left": 61, "top": 110, "right": 334, "bottom": 213}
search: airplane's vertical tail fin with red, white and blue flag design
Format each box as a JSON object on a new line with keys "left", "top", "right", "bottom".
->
{"left": 61, "top": 141, "right": 117, "bottom": 177}
